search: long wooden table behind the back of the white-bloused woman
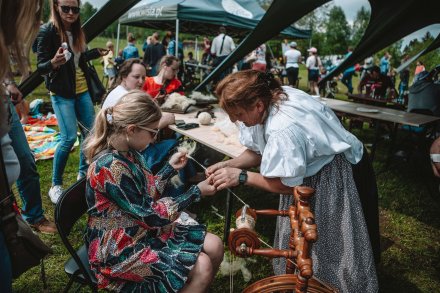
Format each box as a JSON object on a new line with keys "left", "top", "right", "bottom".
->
{"left": 321, "top": 98, "right": 440, "bottom": 160}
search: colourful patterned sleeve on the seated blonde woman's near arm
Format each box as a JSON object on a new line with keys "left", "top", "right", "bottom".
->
{"left": 90, "top": 156, "right": 201, "bottom": 228}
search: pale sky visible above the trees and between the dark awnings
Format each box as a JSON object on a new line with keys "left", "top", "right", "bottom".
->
{"left": 87, "top": 0, "right": 440, "bottom": 49}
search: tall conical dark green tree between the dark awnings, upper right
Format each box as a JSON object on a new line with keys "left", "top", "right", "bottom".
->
{"left": 320, "top": 6, "right": 350, "bottom": 55}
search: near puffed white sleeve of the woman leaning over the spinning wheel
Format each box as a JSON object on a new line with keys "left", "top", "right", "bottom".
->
{"left": 260, "top": 128, "right": 307, "bottom": 186}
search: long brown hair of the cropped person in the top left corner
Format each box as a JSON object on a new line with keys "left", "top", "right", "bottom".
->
{"left": 0, "top": 0, "right": 43, "bottom": 81}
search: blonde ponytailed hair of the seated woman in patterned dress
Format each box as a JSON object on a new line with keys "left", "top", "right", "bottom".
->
{"left": 84, "top": 90, "right": 162, "bottom": 162}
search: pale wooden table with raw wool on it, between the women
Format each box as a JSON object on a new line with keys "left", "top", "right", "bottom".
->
{"left": 168, "top": 107, "right": 246, "bottom": 243}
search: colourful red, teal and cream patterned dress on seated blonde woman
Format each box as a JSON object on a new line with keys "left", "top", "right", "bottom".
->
{"left": 85, "top": 150, "right": 206, "bottom": 292}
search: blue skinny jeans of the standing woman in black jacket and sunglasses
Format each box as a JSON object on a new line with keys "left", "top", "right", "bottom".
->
{"left": 50, "top": 92, "right": 95, "bottom": 185}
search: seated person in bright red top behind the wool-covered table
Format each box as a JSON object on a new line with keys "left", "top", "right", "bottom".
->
{"left": 142, "top": 55, "right": 184, "bottom": 105}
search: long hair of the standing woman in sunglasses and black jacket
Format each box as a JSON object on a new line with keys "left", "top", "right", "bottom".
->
{"left": 50, "top": 0, "right": 86, "bottom": 52}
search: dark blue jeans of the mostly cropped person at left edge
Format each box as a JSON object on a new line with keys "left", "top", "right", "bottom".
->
{"left": 9, "top": 103, "right": 44, "bottom": 224}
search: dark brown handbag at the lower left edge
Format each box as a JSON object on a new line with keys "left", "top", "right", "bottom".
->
{"left": 0, "top": 149, "right": 52, "bottom": 278}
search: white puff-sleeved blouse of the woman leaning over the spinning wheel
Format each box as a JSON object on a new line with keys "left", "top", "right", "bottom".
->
{"left": 239, "top": 87, "right": 363, "bottom": 186}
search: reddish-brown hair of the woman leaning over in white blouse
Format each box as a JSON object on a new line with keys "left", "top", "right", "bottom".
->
{"left": 215, "top": 70, "right": 285, "bottom": 112}
